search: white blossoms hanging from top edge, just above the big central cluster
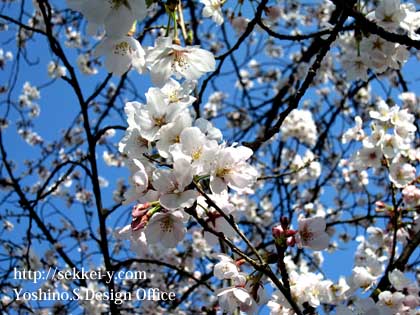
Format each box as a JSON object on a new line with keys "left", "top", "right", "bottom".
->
{"left": 67, "top": 0, "right": 215, "bottom": 78}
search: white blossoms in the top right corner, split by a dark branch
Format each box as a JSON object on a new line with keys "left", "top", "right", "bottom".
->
{"left": 340, "top": 0, "right": 420, "bottom": 81}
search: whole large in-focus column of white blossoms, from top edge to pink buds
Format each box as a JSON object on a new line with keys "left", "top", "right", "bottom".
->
{"left": 68, "top": 0, "right": 257, "bottom": 254}
